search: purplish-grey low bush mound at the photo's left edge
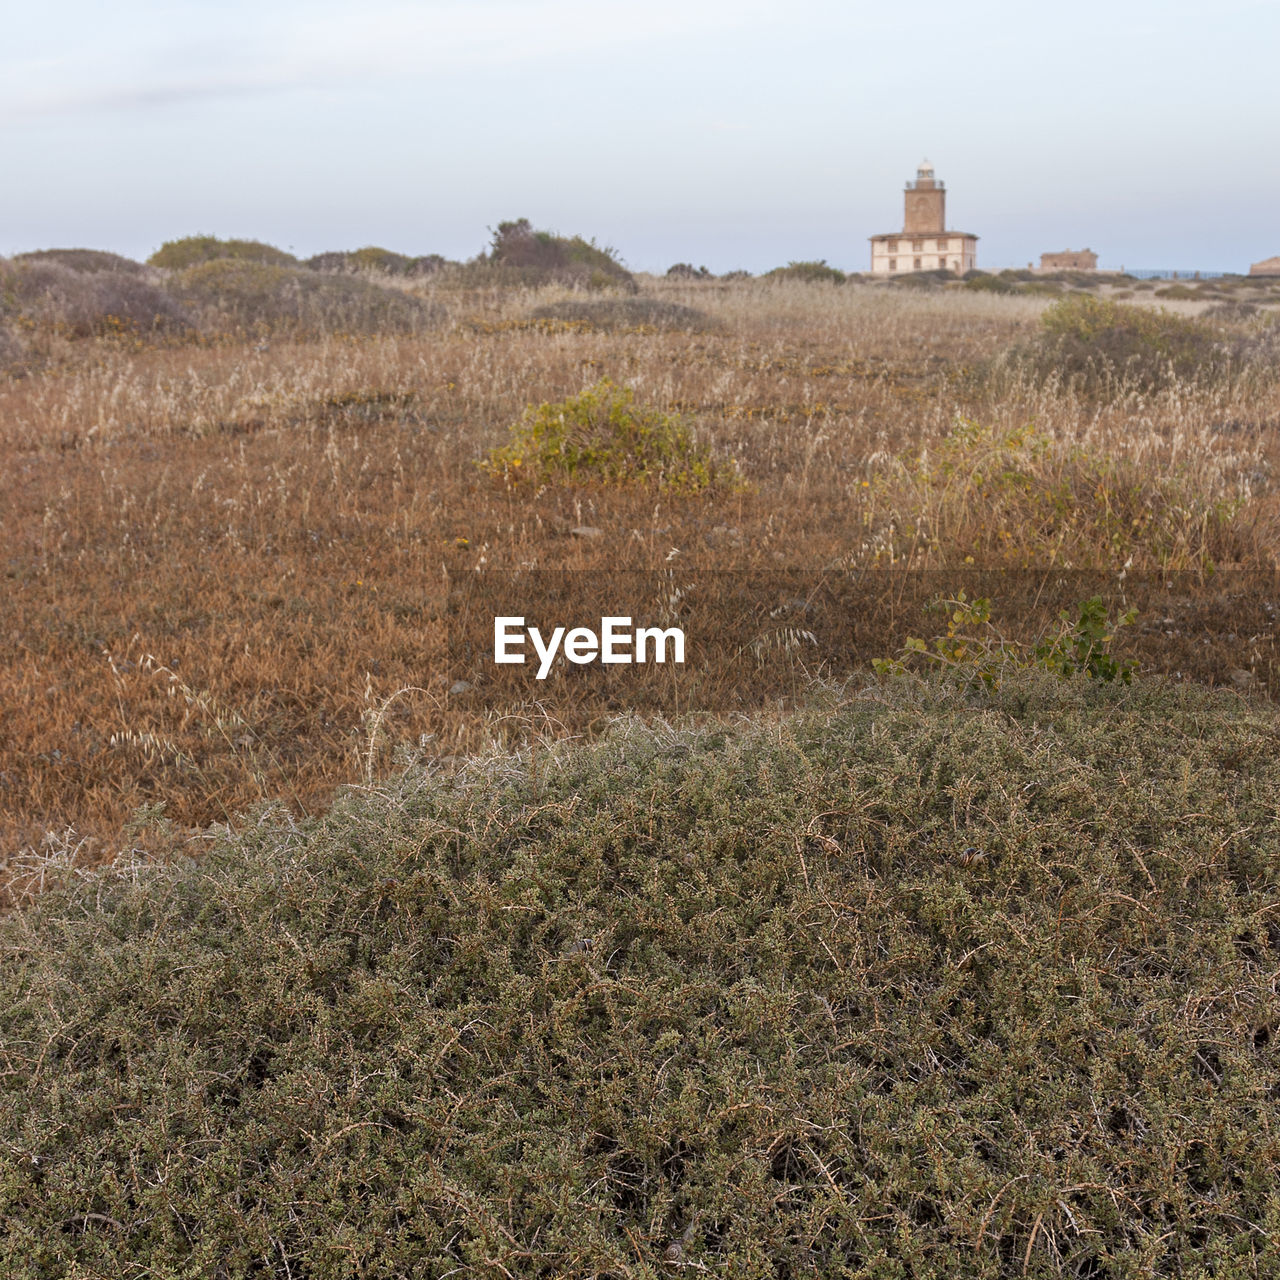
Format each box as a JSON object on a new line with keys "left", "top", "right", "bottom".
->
{"left": 0, "top": 260, "right": 191, "bottom": 338}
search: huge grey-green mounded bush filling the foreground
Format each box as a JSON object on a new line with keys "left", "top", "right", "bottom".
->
{"left": 0, "top": 675, "right": 1280, "bottom": 1280}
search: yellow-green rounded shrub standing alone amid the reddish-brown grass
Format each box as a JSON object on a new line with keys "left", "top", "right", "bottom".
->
{"left": 481, "top": 379, "right": 739, "bottom": 493}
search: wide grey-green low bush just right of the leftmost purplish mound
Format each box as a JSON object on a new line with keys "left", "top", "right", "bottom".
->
{"left": 172, "top": 259, "right": 443, "bottom": 335}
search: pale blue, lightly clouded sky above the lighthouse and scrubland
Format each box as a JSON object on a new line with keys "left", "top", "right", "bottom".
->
{"left": 0, "top": 0, "right": 1280, "bottom": 273}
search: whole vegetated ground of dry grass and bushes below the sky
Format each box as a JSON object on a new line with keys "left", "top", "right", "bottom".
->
{"left": 0, "top": 254, "right": 1280, "bottom": 1280}
